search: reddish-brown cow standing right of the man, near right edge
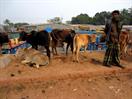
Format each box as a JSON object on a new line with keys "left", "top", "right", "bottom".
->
{"left": 119, "top": 31, "right": 129, "bottom": 58}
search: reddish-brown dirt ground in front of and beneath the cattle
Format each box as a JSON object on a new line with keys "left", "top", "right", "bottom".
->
{"left": 0, "top": 51, "right": 132, "bottom": 99}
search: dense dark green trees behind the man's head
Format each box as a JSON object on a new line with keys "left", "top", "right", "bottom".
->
{"left": 71, "top": 8, "right": 132, "bottom": 25}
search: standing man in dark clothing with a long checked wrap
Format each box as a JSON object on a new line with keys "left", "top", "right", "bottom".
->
{"left": 103, "top": 10, "right": 124, "bottom": 68}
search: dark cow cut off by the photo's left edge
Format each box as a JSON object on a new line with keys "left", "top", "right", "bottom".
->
{"left": 0, "top": 33, "right": 12, "bottom": 53}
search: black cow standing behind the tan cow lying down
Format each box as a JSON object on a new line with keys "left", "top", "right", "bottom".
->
{"left": 19, "top": 30, "right": 50, "bottom": 60}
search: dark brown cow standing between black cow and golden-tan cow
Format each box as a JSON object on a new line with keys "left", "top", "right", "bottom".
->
{"left": 51, "top": 29, "right": 76, "bottom": 55}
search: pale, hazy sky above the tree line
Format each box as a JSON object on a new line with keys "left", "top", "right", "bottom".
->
{"left": 0, "top": 0, "right": 132, "bottom": 24}
